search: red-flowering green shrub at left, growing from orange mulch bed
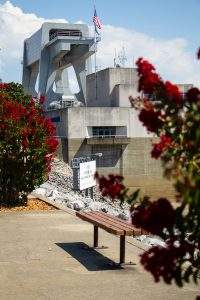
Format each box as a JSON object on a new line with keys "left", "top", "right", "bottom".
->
{"left": 0, "top": 83, "right": 58, "bottom": 206}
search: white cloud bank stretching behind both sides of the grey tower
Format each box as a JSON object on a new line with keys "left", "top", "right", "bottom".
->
{"left": 0, "top": 1, "right": 200, "bottom": 86}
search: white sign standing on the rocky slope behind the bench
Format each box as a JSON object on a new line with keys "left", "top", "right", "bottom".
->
{"left": 80, "top": 160, "right": 96, "bottom": 191}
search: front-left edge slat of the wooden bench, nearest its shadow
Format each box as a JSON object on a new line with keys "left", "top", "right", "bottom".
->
{"left": 76, "top": 212, "right": 124, "bottom": 235}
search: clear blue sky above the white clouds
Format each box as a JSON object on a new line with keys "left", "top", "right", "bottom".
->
{"left": 11, "top": 0, "right": 200, "bottom": 47}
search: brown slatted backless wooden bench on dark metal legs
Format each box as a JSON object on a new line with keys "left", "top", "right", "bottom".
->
{"left": 76, "top": 211, "right": 144, "bottom": 264}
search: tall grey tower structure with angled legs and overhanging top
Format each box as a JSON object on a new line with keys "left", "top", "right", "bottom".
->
{"left": 22, "top": 23, "right": 95, "bottom": 110}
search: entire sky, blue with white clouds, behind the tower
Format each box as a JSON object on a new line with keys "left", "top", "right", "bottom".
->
{"left": 0, "top": 0, "right": 200, "bottom": 85}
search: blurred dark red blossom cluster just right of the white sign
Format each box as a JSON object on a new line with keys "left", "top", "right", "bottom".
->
{"left": 95, "top": 172, "right": 124, "bottom": 199}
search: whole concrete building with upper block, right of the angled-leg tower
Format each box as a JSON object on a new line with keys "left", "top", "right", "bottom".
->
{"left": 46, "top": 68, "right": 174, "bottom": 198}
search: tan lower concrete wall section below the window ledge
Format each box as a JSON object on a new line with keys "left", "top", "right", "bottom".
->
{"left": 68, "top": 138, "right": 175, "bottom": 201}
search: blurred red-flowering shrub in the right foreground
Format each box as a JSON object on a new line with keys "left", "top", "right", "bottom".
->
{"left": 96, "top": 49, "right": 200, "bottom": 286}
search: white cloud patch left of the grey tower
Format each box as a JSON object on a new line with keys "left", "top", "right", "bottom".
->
{"left": 0, "top": 1, "right": 67, "bottom": 81}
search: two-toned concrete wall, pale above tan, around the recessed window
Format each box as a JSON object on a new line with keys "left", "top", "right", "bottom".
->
{"left": 47, "top": 107, "right": 174, "bottom": 199}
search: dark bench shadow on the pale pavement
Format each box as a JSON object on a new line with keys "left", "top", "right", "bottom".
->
{"left": 56, "top": 242, "right": 123, "bottom": 271}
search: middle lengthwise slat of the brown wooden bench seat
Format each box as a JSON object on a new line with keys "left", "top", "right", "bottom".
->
{"left": 87, "top": 212, "right": 133, "bottom": 235}
